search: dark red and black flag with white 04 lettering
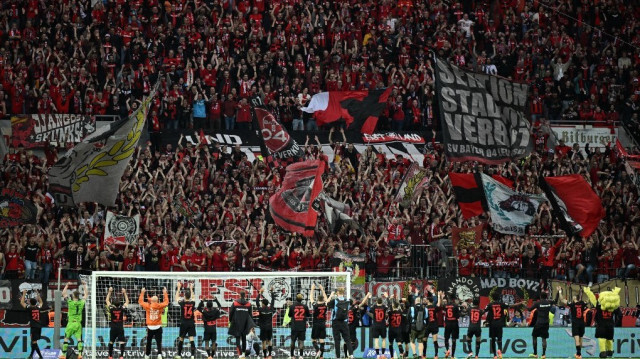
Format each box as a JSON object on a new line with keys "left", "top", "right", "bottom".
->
{"left": 254, "top": 107, "right": 304, "bottom": 159}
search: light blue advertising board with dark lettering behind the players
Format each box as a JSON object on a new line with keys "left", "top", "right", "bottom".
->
{"left": 0, "top": 327, "right": 640, "bottom": 359}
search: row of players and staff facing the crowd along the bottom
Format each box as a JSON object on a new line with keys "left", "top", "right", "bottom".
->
{"left": 20, "top": 282, "right": 619, "bottom": 359}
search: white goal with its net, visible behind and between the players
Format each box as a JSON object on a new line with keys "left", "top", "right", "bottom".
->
{"left": 83, "top": 271, "right": 351, "bottom": 359}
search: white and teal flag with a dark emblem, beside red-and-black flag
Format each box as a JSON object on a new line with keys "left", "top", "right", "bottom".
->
{"left": 480, "top": 173, "right": 547, "bottom": 235}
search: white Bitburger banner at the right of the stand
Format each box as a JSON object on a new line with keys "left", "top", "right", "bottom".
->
{"left": 551, "top": 125, "right": 618, "bottom": 148}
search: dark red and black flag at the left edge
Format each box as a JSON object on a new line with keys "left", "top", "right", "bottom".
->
{"left": 0, "top": 188, "right": 38, "bottom": 228}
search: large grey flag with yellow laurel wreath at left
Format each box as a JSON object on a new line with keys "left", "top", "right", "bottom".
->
{"left": 49, "top": 88, "right": 156, "bottom": 206}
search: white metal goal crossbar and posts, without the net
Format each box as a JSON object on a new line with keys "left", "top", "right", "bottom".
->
{"left": 85, "top": 271, "right": 351, "bottom": 359}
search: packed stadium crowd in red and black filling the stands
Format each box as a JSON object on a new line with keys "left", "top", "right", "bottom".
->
{"left": 0, "top": 0, "right": 640, "bottom": 283}
